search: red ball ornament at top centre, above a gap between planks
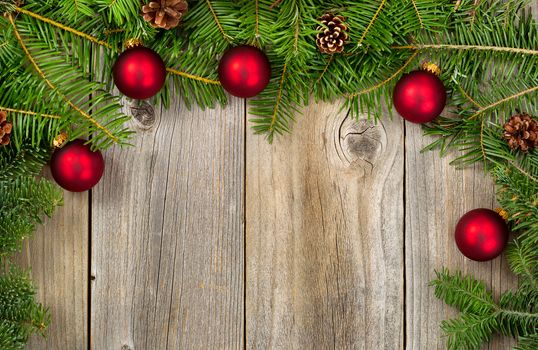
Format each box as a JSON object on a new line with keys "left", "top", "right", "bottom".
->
{"left": 219, "top": 45, "right": 271, "bottom": 98}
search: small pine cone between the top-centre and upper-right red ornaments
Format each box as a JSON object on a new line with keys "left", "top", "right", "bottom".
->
{"left": 316, "top": 13, "right": 349, "bottom": 54}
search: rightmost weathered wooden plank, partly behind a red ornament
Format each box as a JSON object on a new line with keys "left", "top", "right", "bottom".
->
{"left": 405, "top": 123, "right": 516, "bottom": 349}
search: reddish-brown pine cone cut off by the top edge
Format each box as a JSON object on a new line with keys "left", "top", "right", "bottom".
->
{"left": 142, "top": 0, "right": 189, "bottom": 29}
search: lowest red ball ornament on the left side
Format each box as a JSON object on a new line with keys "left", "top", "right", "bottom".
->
{"left": 50, "top": 139, "right": 105, "bottom": 192}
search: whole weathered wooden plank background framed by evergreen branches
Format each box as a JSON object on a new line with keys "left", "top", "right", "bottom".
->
{"left": 13, "top": 93, "right": 516, "bottom": 350}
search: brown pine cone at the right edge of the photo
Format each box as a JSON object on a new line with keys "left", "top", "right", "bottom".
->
{"left": 503, "top": 113, "right": 538, "bottom": 152}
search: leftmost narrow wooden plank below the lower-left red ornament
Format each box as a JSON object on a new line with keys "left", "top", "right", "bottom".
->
{"left": 16, "top": 185, "right": 89, "bottom": 350}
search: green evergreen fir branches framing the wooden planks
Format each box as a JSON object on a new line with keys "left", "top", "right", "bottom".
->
{"left": 0, "top": 0, "right": 538, "bottom": 350}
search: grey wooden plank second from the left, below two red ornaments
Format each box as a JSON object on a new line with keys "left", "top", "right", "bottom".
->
{"left": 91, "top": 99, "right": 245, "bottom": 350}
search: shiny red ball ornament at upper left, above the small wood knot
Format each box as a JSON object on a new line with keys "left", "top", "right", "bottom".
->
{"left": 112, "top": 46, "right": 166, "bottom": 100}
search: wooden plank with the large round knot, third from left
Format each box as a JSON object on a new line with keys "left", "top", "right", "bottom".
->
{"left": 246, "top": 104, "right": 404, "bottom": 349}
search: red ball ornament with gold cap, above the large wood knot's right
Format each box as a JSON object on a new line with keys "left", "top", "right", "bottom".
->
{"left": 393, "top": 64, "right": 446, "bottom": 123}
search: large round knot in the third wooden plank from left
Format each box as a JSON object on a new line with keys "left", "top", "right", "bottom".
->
{"left": 335, "top": 116, "right": 387, "bottom": 176}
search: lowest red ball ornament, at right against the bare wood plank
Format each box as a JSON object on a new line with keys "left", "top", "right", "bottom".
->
{"left": 455, "top": 208, "right": 509, "bottom": 261}
